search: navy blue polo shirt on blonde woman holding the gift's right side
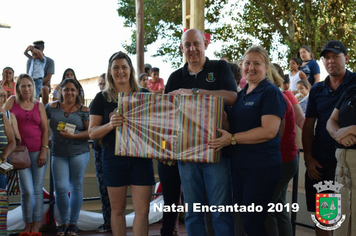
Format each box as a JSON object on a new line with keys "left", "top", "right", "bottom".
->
{"left": 227, "top": 79, "right": 286, "bottom": 168}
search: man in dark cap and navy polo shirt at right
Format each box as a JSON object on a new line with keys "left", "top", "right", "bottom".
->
{"left": 302, "top": 40, "right": 356, "bottom": 236}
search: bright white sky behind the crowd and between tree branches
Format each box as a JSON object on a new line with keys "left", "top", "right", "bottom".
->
{"left": 0, "top": 0, "right": 324, "bottom": 96}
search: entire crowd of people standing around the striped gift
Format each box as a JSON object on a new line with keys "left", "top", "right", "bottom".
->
{"left": 0, "top": 29, "right": 356, "bottom": 236}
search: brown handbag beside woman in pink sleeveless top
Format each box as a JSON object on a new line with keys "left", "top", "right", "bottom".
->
{"left": 9, "top": 139, "right": 31, "bottom": 170}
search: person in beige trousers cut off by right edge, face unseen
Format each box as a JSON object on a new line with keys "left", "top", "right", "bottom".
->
{"left": 326, "top": 85, "right": 356, "bottom": 236}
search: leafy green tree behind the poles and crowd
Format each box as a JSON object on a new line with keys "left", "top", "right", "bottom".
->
{"left": 118, "top": 0, "right": 356, "bottom": 70}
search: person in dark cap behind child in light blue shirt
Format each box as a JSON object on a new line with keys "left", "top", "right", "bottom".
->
{"left": 27, "top": 40, "right": 54, "bottom": 105}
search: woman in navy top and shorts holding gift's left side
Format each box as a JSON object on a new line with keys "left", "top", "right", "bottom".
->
{"left": 89, "top": 52, "right": 155, "bottom": 236}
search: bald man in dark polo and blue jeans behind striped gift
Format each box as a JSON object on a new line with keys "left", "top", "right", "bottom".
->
{"left": 162, "top": 29, "right": 237, "bottom": 236}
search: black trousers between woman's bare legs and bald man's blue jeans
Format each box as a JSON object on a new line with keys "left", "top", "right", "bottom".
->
{"left": 158, "top": 162, "right": 180, "bottom": 236}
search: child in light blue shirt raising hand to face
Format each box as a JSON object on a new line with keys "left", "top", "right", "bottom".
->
{"left": 24, "top": 45, "right": 46, "bottom": 100}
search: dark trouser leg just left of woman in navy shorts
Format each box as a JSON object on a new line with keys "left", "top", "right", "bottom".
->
{"left": 94, "top": 150, "right": 111, "bottom": 225}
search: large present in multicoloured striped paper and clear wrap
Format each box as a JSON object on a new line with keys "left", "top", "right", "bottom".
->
{"left": 115, "top": 93, "right": 224, "bottom": 163}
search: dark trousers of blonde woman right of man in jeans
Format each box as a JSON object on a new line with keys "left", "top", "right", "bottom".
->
{"left": 232, "top": 164, "right": 282, "bottom": 236}
